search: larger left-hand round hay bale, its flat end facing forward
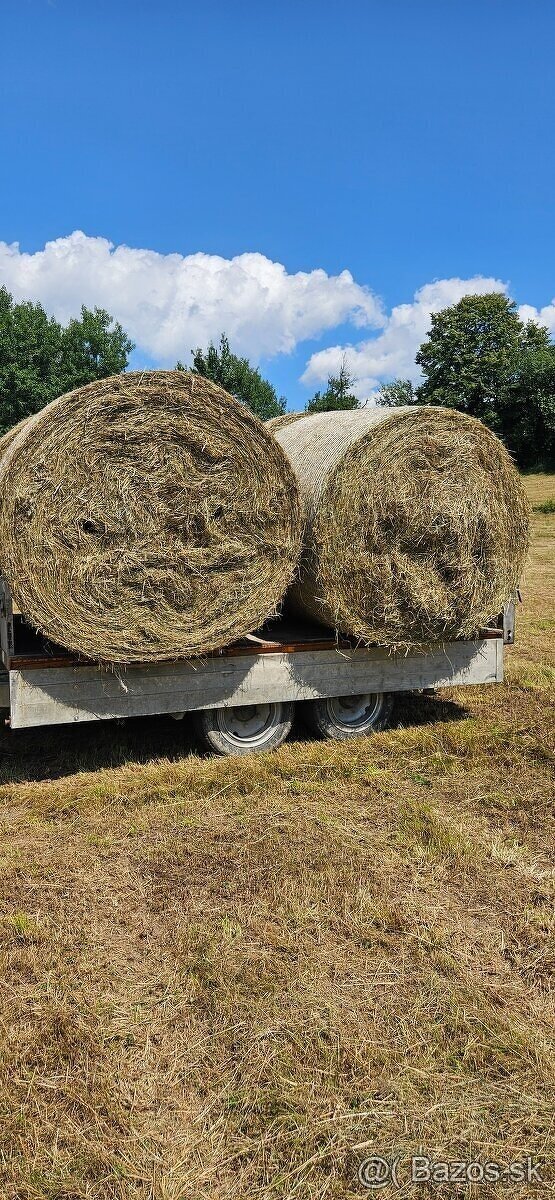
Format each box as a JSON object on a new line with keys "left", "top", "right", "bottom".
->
{"left": 0, "top": 371, "right": 300, "bottom": 662}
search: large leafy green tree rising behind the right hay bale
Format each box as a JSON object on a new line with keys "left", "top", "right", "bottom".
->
{"left": 416, "top": 293, "right": 555, "bottom": 467}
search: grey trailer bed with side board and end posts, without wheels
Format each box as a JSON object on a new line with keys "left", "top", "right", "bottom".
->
{"left": 0, "top": 577, "right": 514, "bottom": 730}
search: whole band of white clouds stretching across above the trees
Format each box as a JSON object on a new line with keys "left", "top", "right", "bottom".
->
{"left": 0, "top": 232, "right": 555, "bottom": 398}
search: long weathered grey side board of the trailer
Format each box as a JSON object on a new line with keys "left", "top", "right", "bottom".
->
{"left": 4, "top": 637, "right": 503, "bottom": 728}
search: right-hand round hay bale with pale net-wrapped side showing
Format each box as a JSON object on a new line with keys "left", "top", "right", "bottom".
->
{"left": 274, "top": 407, "right": 529, "bottom": 647}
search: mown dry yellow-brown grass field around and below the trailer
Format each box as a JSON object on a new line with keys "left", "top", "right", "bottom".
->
{"left": 0, "top": 475, "right": 555, "bottom": 1200}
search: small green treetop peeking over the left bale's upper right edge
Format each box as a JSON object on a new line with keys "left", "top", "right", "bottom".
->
{"left": 191, "top": 334, "right": 286, "bottom": 421}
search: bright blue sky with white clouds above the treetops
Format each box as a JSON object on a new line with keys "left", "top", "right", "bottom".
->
{"left": 0, "top": 0, "right": 555, "bottom": 407}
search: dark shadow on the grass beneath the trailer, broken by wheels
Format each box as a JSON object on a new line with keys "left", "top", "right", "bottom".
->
{"left": 0, "top": 694, "right": 467, "bottom": 785}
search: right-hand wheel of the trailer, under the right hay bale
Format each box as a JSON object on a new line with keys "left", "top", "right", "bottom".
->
{"left": 303, "top": 691, "right": 393, "bottom": 740}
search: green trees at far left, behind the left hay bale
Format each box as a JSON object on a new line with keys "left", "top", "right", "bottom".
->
{"left": 0, "top": 288, "right": 133, "bottom": 433}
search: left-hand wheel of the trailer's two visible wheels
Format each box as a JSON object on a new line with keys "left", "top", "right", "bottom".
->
{"left": 193, "top": 702, "right": 293, "bottom": 755}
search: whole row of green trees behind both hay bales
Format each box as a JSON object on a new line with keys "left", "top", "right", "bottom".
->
{"left": 0, "top": 288, "right": 555, "bottom": 470}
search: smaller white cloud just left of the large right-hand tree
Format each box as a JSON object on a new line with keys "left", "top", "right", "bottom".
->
{"left": 303, "top": 275, "right": 507, "bottom": 398}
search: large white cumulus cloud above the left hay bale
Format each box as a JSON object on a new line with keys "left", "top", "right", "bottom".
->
{"left": 0, "top": 232, "right": 384, "bottom": 366}
